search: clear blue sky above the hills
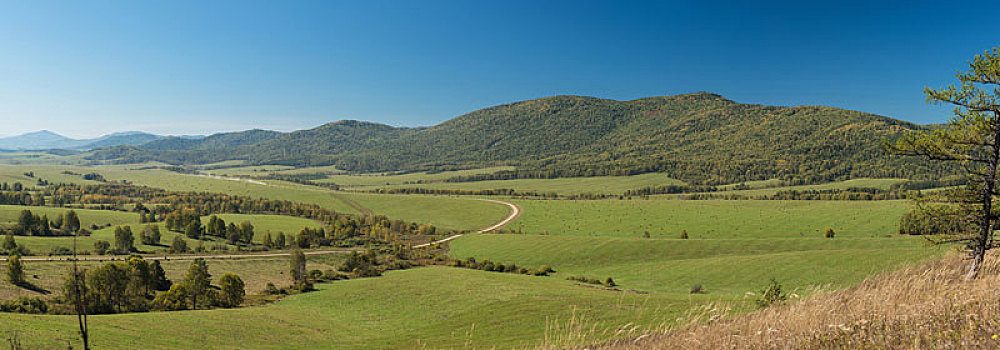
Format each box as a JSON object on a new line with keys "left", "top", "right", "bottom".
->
{"left": 0, "top": 0, "right": 1000, "bottom": 137}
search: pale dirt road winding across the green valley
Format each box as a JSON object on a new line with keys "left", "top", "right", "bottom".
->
{"left": 0, "top": 198, "right": 521, "bottom": 262}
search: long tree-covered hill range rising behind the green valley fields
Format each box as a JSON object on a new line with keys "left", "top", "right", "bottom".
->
{"left": 88, "top": 93, "right": 951, "bottom": 183}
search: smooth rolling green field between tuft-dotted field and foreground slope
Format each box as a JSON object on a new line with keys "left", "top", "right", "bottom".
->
{"left": 451, "top": 234, "right": 944, "bottom": 297}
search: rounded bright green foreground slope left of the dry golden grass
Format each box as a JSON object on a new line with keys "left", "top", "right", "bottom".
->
{"left": 0, "top": 267, "right": 711, "bottom": 349}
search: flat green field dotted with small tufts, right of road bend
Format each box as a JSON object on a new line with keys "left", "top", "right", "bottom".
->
{"left": 507, "top": 200, "right": 911, "bottom": 239}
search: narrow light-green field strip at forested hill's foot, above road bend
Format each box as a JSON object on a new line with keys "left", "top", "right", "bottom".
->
{"left": 379, "top": 173, "right": 684, "bottom": 195}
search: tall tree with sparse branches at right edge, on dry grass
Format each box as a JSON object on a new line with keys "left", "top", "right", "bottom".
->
{"left": 890, "top": 48, "right": 1000, "bottom": 279}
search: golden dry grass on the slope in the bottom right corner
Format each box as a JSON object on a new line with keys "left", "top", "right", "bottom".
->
{"left": 540, "top": 250, "right": 1000, "bottom": 349}
